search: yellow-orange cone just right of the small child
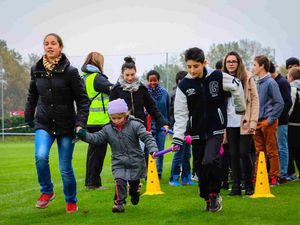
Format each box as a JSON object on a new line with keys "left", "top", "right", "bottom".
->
{"left": 143, "top": 155, "right": 164, "bottom": 195}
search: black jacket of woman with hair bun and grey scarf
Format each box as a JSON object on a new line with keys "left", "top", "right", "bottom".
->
{"left": 109, "top": 82, "right": 169, "bottom": 127}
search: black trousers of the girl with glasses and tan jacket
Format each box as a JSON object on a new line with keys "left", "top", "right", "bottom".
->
{"left": 226, "top": 127, "right": 253, "bottom": 190}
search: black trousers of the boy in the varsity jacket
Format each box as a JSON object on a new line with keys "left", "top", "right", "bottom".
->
{"left": 192, "top": 135, "right": 223, "bottom": 200}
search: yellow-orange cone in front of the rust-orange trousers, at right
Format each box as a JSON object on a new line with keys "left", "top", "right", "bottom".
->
{"left": 250, "top": 152, "right": 275, "bottom": 198}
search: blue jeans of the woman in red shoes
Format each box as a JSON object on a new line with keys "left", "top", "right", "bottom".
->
{"left": 35, "top": 129, "right": 77, "bottom": 203}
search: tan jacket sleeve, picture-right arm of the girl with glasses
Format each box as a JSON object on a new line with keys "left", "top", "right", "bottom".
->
{"left": 249, "top": 77, "right": 259, "bottom": 129}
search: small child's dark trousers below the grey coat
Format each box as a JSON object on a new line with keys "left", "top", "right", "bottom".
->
{"left": 114, "top": 178, "right": 140, "bottom": 205}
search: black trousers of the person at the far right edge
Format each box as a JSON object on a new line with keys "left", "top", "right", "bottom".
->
{"left": 287, "top": 125, "right": 300, "bottom": 175}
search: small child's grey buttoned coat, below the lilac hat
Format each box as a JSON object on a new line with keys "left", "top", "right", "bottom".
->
{"left": 84, "top": 116, "right": 158, "bottom": 180}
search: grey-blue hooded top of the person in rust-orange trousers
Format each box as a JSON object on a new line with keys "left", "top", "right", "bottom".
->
{"left": 256, "top": 74, "right": 284, "bottom": 124}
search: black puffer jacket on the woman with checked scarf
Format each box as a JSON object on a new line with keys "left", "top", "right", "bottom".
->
{"left": 25, "top": 54, "right": 89, "bottom": 136}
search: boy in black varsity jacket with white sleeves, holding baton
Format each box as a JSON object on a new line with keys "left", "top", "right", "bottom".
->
{"left": 173, "top": 48, "right": 245, "bottom": 212}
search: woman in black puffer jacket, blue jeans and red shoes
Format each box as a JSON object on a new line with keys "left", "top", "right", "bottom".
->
{"left": 25, "top": 33, "right": 89, "bottom": 213}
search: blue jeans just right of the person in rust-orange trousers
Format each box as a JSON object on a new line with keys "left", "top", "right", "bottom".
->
{"left": 277, "top": 124, "right": 289, "bottom": 176}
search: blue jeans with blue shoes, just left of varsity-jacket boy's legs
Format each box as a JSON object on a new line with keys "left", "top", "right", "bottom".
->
{"left": 170, "top": 144, "right": 191, "bottom": 181}
